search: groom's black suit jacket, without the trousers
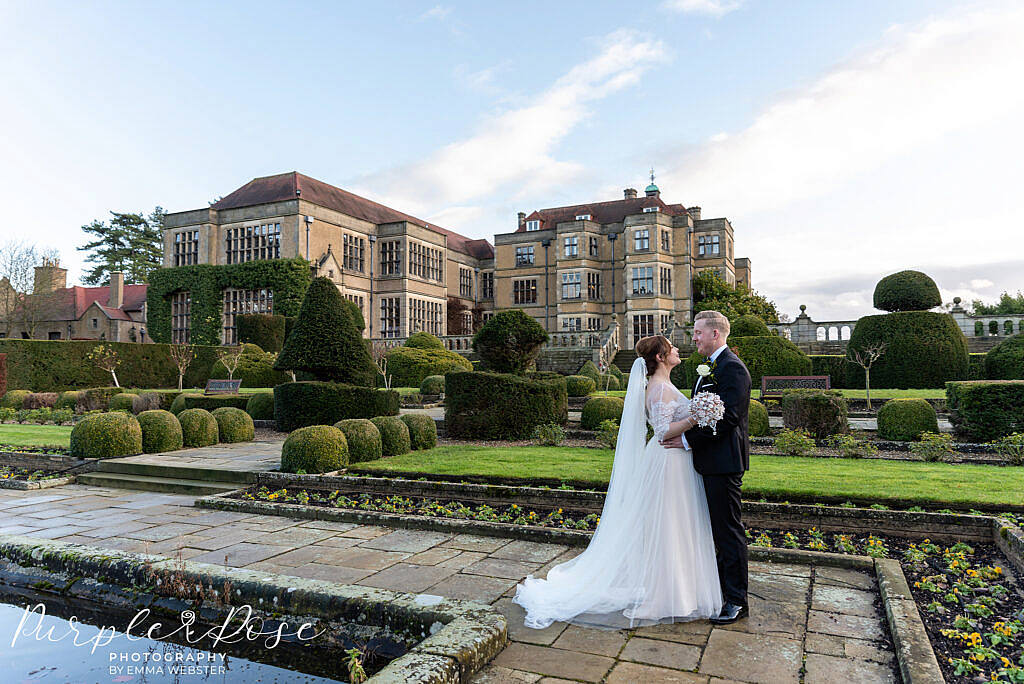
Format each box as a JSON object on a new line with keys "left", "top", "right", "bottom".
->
{"left": 686, "top": 347, "right": 751, "bottom": 475}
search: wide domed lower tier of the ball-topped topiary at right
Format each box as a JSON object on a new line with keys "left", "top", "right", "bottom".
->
{"left": 847, "top": 311, "right": 969, "bottom": 389}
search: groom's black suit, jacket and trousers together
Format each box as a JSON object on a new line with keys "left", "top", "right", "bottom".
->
{"left": 686, "top": 347, "right": 751, "bottom": 606}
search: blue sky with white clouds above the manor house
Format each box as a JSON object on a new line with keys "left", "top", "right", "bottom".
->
{"left": 0, "top": 0, "right": 1024, "bottom": 319}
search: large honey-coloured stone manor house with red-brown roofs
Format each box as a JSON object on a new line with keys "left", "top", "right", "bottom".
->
{"left": 164, "top": 172, "right": 751, "bottom": 358}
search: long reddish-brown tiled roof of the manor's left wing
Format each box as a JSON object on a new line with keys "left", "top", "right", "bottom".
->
{"left": 213, "top": 171, "right": 495, "bottom": 259}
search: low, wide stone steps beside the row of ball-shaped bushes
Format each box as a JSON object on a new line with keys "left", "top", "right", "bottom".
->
{"left": 75, "top": 459, "right": 255, "bottom": 497}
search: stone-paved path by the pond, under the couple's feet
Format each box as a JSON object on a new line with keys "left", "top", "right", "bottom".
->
{"left": 0, "top": 485, "right": 898, "bottom": 684}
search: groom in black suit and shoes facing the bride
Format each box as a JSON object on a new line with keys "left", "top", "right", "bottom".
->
{"left": 662, "top": 311, "right": 751, "bottom": 625}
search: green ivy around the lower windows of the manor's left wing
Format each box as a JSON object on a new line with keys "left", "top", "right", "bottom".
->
{"left": 146, "top": 258, "right": 312, "bottom": 344}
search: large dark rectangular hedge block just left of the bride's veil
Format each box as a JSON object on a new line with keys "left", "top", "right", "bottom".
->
{"left": 444, "top": 371, "right": 568, "bottom": 439}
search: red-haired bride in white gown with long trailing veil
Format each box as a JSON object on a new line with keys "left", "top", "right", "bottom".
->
{"left": 512, "top": 335, "right": 723, "bottom": 629}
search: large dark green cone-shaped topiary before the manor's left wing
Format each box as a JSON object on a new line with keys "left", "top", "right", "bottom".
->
{"left": 274, "top": 277, "right": 377, "bottom": 387}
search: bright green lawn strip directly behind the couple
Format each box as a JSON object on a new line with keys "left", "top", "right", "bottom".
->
{"left": 358, "top": 446, "right": 1024, "bottom": 509}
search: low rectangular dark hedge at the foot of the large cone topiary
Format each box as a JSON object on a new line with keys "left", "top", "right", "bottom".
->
{"left": 273, "top": 382, "right": 399, "bottom": 432}
